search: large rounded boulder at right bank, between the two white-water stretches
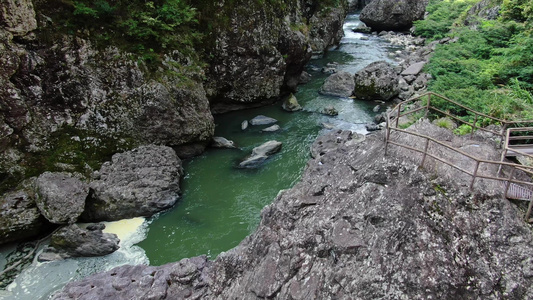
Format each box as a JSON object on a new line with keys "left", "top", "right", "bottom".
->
{"left": 353, "top": 61, "right": 400, "bottom": 101}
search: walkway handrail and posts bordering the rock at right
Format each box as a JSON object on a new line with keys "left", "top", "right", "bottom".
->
{"left": 385, "top": 92, "right": 533, "bottom": 220}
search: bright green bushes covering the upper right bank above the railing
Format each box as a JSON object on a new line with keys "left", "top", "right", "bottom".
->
{"left": 415, "top": 0, "right": 533, "bottom": 123}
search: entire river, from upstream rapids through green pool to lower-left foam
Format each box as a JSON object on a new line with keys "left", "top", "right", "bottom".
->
{"left": 0, "top": 14, "right": 395, "bottom": 300}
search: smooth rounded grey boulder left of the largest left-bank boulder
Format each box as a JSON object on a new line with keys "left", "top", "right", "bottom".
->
{"left": 35, "top": 172, "right": 89, "bottom": 224}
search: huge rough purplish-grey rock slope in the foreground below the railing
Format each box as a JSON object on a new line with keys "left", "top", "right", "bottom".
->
{"left": 56, "top": 122, "right": 533, "bottom": 299}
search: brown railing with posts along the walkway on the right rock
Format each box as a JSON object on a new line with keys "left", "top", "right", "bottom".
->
{"left": 385, "top": 92, "right": 533, "bottom": 220}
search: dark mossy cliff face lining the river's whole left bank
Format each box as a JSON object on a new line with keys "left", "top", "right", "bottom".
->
{"left": 0, "top": 0, "right": 346, "bottom": 192}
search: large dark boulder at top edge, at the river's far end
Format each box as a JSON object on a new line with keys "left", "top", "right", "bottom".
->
{"left": 360, "top": 0, "right": 428, "bottom": 31}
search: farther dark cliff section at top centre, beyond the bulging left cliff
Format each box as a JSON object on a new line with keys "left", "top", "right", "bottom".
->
{"left": 207, "top": 0, "right": 347, "bottom": 113}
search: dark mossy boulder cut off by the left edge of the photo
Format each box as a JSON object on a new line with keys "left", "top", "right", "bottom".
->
{"left": 0, "top": 184, "right": 49, "bottom": 244}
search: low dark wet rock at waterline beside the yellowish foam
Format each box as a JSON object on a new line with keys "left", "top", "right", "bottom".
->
{"left": 39, "top": 224, "right": 120, "bottom": 261}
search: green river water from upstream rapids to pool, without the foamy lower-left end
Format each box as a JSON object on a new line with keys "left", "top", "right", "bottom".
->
{"left": 139, "top": 15, "right": 394, "bottom": 265}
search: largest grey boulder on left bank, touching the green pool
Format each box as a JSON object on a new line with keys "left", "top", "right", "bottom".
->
{"left": 82, "top": 145, "right": 183, "bottom": 221}
